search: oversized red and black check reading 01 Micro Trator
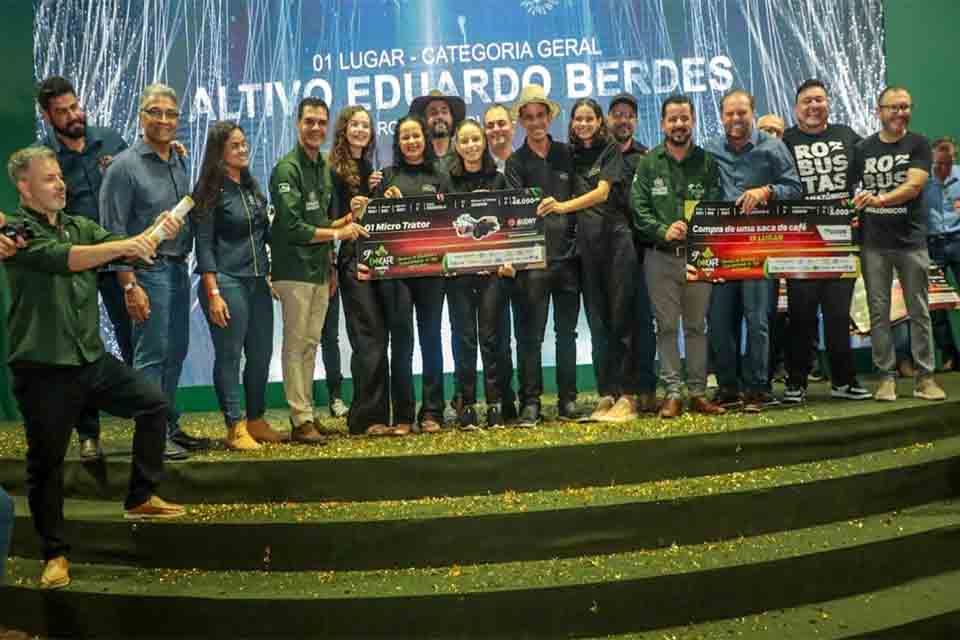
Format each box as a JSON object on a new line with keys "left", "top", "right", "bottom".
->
{"left": 358, "top": 189, "right": 547, "bottom": 279}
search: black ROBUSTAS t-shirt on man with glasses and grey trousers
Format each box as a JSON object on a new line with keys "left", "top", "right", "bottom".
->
{"left": 856, "top": 132, "right": 933, "bottom": 249}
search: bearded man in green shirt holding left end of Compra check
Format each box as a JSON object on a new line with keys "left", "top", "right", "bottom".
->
{"left": 631, "top": 95, "right": 724, "bottom": 418}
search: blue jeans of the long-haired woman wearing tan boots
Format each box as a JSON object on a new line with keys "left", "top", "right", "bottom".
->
{"left": 199, "top": 273, "right": 273, "bottom": 427}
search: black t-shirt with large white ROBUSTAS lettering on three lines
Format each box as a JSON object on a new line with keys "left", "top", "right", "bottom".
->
{"left": 783, "top": 124, "right": 863, "bottom": 200}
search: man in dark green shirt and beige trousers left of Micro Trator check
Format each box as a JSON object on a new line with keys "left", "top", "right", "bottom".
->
{"left": 270, "top": 97, "right": 367, "bottom": 444}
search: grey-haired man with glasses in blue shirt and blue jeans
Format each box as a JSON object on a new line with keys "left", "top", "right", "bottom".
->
{"left": 100, "top": 84, "right": 209, "bottom": 460}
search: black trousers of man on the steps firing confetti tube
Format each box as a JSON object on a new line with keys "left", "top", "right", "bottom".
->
{"left": 13, "top": 354, "right": 167, "bottom": 560}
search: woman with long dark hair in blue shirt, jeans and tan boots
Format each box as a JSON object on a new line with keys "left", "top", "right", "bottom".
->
{"left": 193, "top": 122, "right": 283, "bottom": 451}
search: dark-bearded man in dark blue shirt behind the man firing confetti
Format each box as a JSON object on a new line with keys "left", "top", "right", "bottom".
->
{"left": 37, "top": 76, "right": 133, "bottom": 460}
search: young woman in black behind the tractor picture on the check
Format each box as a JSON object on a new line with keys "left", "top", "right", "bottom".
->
{"left": 447, "top": 119, "right": 512, "bottom": 429}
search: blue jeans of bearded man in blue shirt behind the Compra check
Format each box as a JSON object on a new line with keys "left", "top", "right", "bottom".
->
{"left": 707, "top": 280, "right": 772, "bottom": 393}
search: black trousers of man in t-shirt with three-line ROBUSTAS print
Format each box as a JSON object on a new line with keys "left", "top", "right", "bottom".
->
{"left": 786, "top": 278, "right": 857, "bottom": 388}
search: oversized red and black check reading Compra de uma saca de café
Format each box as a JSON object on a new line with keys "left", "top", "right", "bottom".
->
{"left": 684, "top": 201, "right": 860, "bottom": 280}
